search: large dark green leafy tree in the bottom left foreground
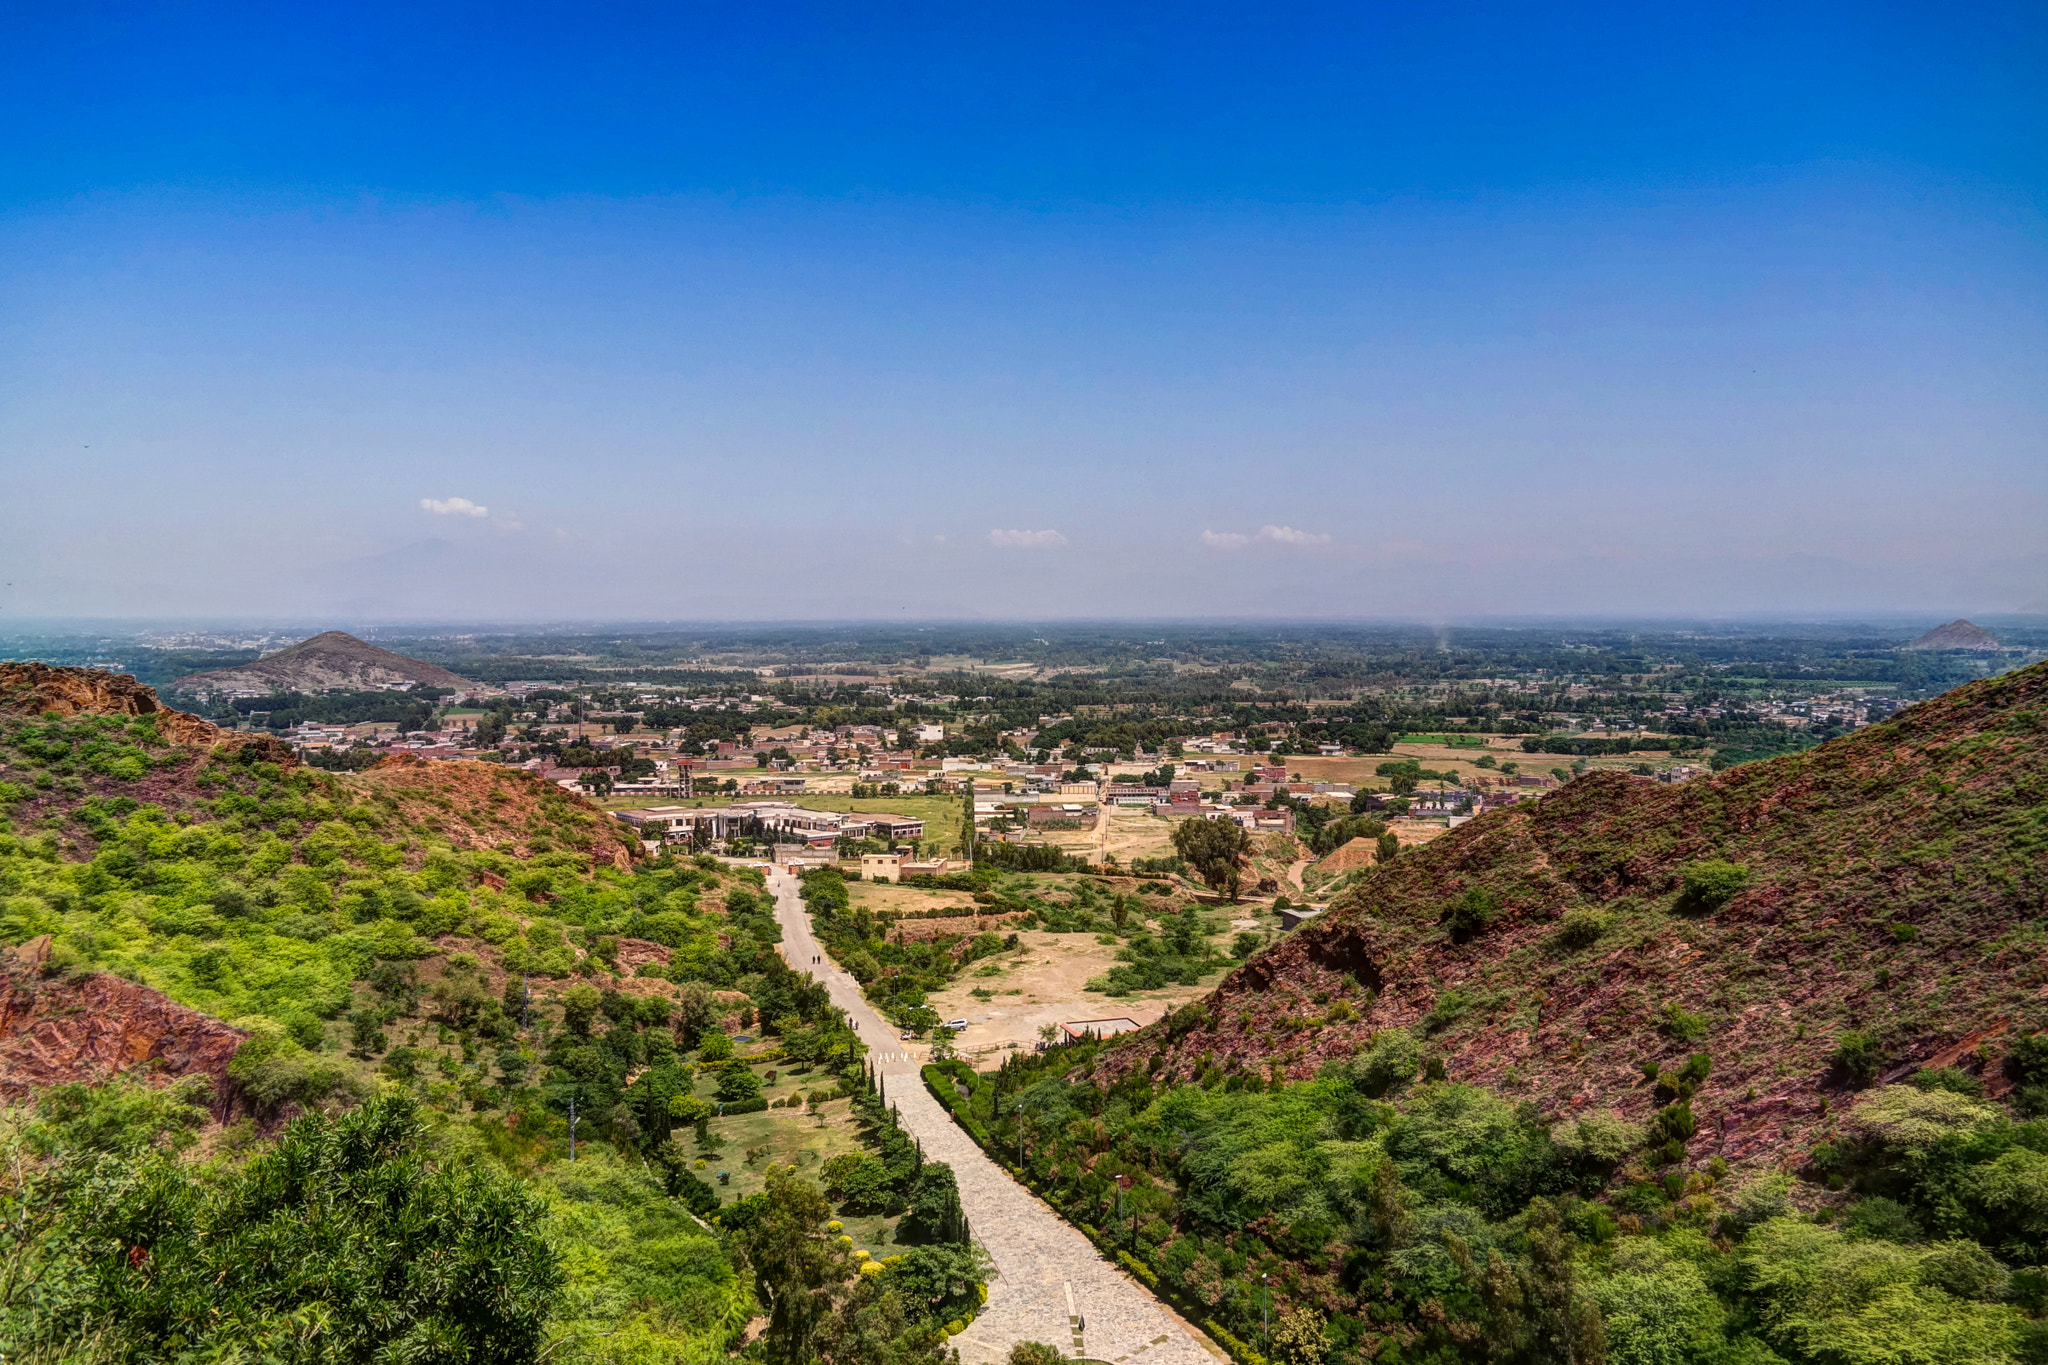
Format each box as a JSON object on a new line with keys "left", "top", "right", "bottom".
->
{"left": 45, "top": 1095, "right": 563, "bottom": 1365}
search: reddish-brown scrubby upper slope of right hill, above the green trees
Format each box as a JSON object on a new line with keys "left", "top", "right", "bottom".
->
{"left": 1098, "top": 665, "right": 2048, "bottom": 1166}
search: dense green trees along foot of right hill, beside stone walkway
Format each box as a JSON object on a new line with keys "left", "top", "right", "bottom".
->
{"left": 948, "top": 1031, "right": 2048, "bottom": 1365}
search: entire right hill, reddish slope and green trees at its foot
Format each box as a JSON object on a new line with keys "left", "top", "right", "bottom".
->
{"left": 946, "top": 665, "right": 2048, "bottom": 1365}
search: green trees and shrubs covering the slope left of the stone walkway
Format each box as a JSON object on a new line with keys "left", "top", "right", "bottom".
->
{"left": 0, "top": 716, "right": 979, "bottom": 1365}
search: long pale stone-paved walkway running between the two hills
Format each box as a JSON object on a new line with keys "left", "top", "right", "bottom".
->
{"left": 768, "top": 872, "right": 1223, "bottom": 1365}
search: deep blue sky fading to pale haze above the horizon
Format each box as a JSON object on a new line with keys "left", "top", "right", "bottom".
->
{"left": 0, "top": 4, "right": 2048, "bottom": 620}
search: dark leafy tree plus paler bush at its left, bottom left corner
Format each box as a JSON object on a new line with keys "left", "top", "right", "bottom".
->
{"left": 0, "top": 1085, "right": 563, "bottom": 1365}
